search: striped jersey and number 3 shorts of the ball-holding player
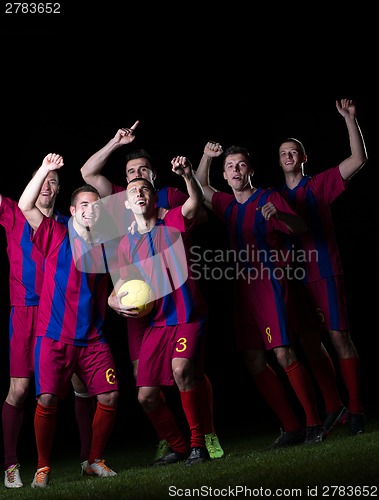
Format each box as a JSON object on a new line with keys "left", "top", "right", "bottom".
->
{"left": 118, "top": 207, "right": 207, "bottom": 387}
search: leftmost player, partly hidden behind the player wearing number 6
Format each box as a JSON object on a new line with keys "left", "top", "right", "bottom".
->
{"left": 0, "top": 166, "right": 93, "bottom": 488}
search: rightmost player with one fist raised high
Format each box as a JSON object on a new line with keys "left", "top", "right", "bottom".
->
{"left": 279, "top": 99, "right": 368, "bottom": 435}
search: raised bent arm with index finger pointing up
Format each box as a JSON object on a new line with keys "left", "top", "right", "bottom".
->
{"left": 80, "top": 120, "right": 139, "bottom": 198}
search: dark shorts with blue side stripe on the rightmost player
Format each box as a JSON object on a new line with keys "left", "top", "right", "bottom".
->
{"left": 305, "top": 275, "right": 349, "bottom": 331}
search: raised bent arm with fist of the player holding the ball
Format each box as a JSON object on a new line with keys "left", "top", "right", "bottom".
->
{"left": 171, "top": 156, "right": 204, "bottom": 219}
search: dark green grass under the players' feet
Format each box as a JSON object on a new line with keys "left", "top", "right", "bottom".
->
{"left": 0, "top": 420, "right": 379, "bottom": 500}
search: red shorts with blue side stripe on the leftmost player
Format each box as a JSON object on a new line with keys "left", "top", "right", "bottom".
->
{"left": 9, "top": 306, "right": 38, "bottom": 378}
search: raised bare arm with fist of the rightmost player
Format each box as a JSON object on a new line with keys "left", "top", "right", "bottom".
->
{"left": 336, "top": 99, "right": 368, "bottom": 179}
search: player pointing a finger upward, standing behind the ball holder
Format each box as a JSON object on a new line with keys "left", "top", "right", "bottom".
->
{"left": 81, "top": 126, "right": 224, "bottom": 459}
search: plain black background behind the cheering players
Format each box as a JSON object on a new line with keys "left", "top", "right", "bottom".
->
{"left": 0, "top": 2, "right": 379, "bottom": 458}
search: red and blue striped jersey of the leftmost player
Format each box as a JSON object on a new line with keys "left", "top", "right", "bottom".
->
{"left": 0, "top": 196, "right": 68, "bottom": 306}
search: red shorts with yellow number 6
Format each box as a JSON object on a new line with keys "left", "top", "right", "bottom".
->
{"left": 35, "top": 337, "right": 119, "bottom": 399}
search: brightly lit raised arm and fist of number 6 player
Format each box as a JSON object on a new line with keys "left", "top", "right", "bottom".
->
{"left": 18, "top": 153, "right": 64, "bottom": 230}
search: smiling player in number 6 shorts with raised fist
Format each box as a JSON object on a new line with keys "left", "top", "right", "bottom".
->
{"left": 19, "top": 153, "right": 119, "bottom": 488}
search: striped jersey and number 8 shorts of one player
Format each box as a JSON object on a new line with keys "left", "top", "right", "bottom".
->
{"left": 212, "top": 188, "right": 306, "bottom": 351}
